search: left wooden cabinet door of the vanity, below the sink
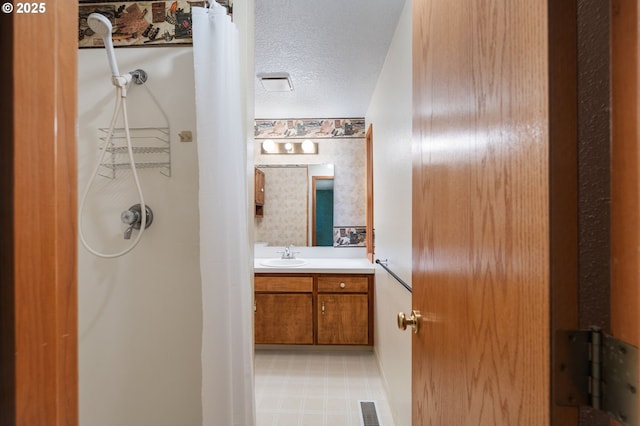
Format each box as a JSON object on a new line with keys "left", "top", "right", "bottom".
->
{"left": 255, "top": 293, "right": 313, "bottom": 344}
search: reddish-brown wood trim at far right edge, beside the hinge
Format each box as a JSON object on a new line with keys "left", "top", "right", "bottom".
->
{"left": 611, "top": 0, "right": 640, "bottom": 346}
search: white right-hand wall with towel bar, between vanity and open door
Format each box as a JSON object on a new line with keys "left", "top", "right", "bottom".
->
{"left": 365, "top": 2, "right": 412, "bottom": 425}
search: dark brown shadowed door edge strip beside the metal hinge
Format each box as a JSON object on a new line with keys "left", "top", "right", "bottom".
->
{"left": 548, "top": 0, "right": 578, "bottom": 425}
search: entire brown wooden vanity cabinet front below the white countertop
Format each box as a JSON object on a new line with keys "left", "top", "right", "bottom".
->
{"left": 255, "top": 274, "right": 373, "bottom": 346}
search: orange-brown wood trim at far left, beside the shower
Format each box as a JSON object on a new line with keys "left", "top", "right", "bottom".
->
{"left": 2, "top": 1, "right": 78, "bottom": 426}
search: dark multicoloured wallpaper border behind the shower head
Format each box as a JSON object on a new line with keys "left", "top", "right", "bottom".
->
{"left": 78, "top": 0, "right": 232, "bottom": 48}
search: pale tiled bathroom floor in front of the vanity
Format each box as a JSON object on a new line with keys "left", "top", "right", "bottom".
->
{"left": 255, "top": 350, "right": 393, "bottom": 426}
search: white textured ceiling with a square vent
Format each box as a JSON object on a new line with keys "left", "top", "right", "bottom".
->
{"left": 255, "top": 0, "right": 405, "bottom": 119}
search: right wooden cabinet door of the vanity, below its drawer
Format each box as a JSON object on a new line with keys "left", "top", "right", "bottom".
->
{"left": 317, "top": 294, "right": 369, "bottom": 345}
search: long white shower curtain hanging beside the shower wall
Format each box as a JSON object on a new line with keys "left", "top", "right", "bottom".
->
{"left": 192, "top": 1, "right": 255, "bottom": 426}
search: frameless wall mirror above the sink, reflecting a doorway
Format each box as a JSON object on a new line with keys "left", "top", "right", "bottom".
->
{"left": 255, "top": 164, "right": 334, "bottom": 246}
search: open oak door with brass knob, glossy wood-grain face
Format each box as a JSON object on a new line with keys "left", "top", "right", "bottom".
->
{"left": 412, "top": 0, "right": 575, "bottom": 426}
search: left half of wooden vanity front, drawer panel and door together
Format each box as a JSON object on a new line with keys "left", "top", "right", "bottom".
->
{"left": 254, "top": 276, "right": 313, "bottom": 344}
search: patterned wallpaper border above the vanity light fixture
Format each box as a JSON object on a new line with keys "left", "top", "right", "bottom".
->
{"left": 254, "top": 118, "right": 365, "bottom": 139}
